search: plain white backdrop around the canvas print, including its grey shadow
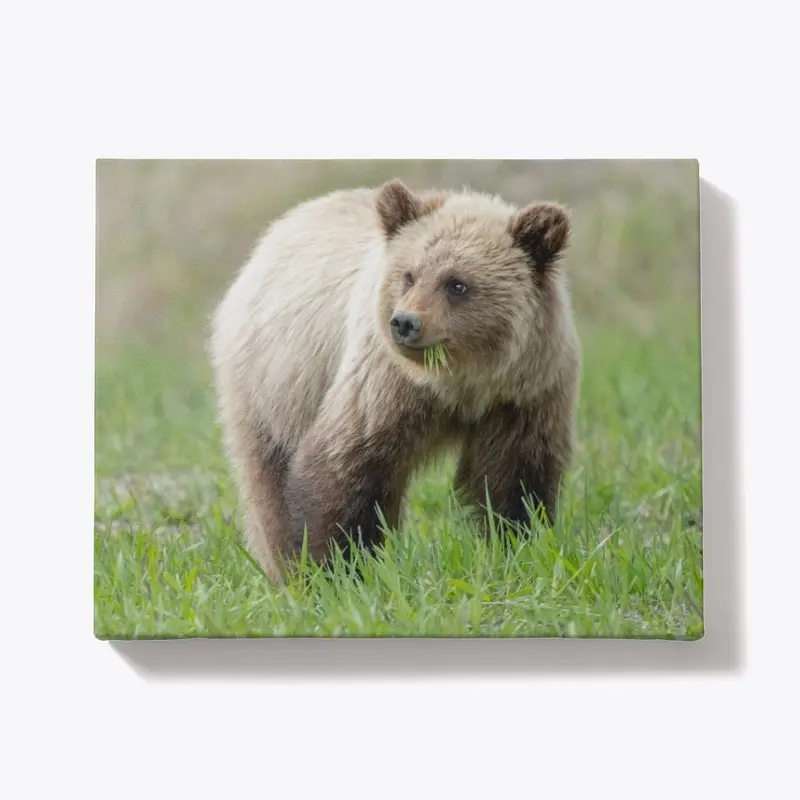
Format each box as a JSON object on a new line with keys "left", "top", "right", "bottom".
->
{"left": 0, "top": 0, "right": 800, "bottom": 798}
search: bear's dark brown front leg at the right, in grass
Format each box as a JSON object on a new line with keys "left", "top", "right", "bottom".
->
{"left": 456, "top": 382, "right": 573, "bottom": 526}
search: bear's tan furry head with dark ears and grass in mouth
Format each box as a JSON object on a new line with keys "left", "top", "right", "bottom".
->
{"left": 375, "top": 180, "right": 571, "bottom": 370}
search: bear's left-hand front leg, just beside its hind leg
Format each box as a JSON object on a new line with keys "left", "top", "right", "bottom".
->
{"left": 286, "top": 388, "right": 432, "bottom": 562}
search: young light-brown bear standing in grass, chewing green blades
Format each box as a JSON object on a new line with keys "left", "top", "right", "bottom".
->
{"left": 210, "top": 179, "right": 581, "bottom": 582}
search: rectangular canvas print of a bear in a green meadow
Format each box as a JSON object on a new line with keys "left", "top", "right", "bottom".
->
{"left": 94, "top": 160, "right": 703, "bottom": 640}
